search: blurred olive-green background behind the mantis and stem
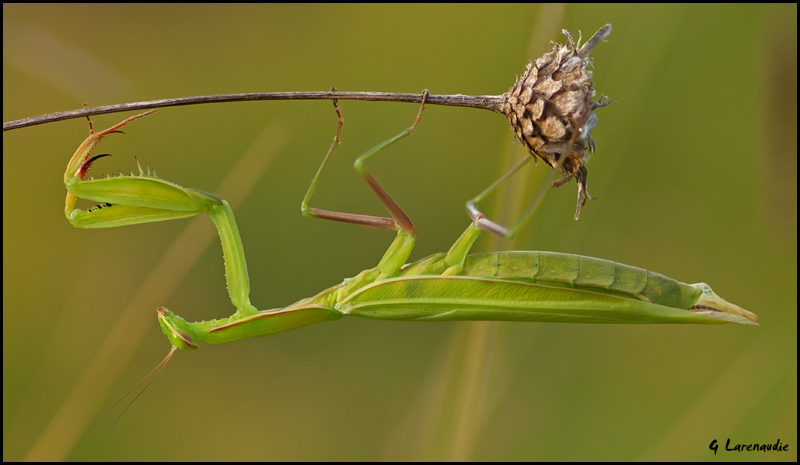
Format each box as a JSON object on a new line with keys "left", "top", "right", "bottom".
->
{"left": 3, "top": 4, "right": 797, "bottom": 461}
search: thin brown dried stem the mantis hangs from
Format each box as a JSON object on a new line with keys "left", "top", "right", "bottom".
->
{"left": 3, "top": 92, "right": 504, "bottom": 131}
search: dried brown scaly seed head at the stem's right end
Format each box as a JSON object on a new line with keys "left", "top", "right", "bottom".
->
{"left": 501, "top": 24, "right": 611, "bottom": 220}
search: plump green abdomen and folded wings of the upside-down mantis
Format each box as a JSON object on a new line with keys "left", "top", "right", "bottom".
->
{"left": 337, "top": 251, "right": 736, "bottom": 323}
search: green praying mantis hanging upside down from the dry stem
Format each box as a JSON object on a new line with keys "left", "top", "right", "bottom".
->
{"left": 64, "top": 98, "right": 757, "bottom": 420}
